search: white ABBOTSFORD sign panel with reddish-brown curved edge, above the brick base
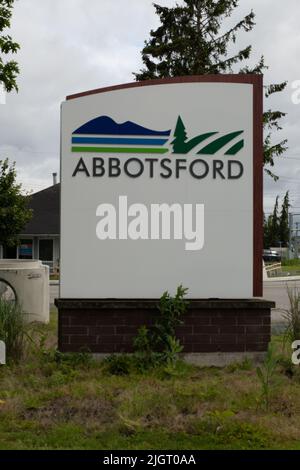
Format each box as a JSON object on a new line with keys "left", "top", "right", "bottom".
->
{"left": 60, "top": 75, "right": 262, "bottom": 299}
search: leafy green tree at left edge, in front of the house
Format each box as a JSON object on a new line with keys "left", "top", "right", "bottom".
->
{"left": 0, "top": 159, "right": 32, "bottom": 246}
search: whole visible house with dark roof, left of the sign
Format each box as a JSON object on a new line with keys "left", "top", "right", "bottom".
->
{"left": 0, "top": 177, "right": 60, "bottom": 271}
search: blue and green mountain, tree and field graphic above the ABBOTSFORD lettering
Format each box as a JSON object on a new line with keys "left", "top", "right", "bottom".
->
{"left": 72, "top": 116, "right": 244, "bottom": 155}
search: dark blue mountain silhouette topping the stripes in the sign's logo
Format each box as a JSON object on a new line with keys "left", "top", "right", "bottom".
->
{"left": 73, "top": 116, "right": 171, "bottom": 136}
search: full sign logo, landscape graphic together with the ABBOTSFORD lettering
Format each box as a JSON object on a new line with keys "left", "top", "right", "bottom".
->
{"left": 71, "top": 116, "right": 244, "bottom": 180}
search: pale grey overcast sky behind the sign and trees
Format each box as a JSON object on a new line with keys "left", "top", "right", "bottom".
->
{"left": 0, "top": 0, "right": 300, "bottom": 213}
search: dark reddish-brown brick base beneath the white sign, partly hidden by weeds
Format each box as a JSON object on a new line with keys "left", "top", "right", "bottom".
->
{"left": 55, "top": 299, "right": 275, "bottom": 353}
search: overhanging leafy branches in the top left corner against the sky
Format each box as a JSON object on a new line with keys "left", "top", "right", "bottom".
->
{"left": 0, "top": 0, "right": 20, "bottom": 92}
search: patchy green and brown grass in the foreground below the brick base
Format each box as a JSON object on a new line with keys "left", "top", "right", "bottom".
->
{"left": 0, "top": 311, "right": 300, "bottom": 450}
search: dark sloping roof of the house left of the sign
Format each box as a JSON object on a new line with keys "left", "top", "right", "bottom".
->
{"left": 22, "top": 183, "right": 60, "bottom": 235}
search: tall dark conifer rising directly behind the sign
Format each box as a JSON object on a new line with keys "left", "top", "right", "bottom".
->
{"left": 134, "top": 0, "right": 287, "bottom": 179}
